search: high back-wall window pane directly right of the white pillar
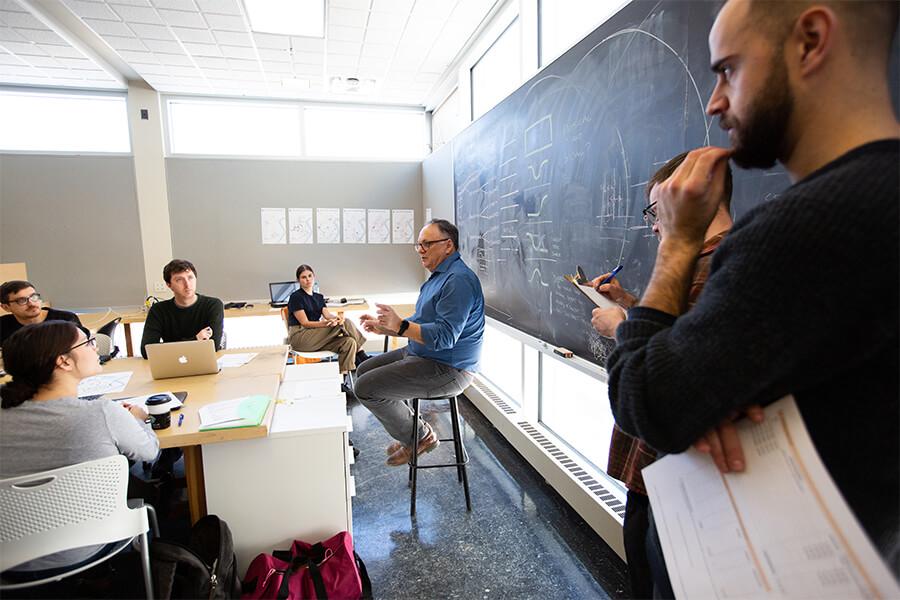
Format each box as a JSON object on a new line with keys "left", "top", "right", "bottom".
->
{"left": 167, "top": 100, "right": 302, "bottom": 157}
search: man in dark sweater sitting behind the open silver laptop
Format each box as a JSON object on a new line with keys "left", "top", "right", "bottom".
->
{"left": 141, "top": 258, "right": 225, "bottom": 358}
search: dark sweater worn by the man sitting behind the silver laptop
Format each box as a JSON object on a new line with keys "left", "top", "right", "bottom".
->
{"left": 141, "top": 294, "right": 225, "bottom": 358}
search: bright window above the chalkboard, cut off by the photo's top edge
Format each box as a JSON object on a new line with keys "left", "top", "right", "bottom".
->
{"left": 539, "top": 0, "right": 629, "bottom": 66}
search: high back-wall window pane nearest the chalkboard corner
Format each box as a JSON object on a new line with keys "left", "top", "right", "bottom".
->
{"left": 303, "top": 107, "right": 427, "bottom": 160}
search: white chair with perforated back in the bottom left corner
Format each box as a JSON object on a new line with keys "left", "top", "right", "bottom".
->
{"left": 0, "top": 455, "right": 153, "bottom": 599}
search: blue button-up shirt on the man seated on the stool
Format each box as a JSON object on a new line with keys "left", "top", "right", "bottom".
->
{"left": 407, "top": 252, "right": 484, "bottom": 372}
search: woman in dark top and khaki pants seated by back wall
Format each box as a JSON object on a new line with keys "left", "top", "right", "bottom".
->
{"left": 288, "top": 265, "right": 369, "bottom": 374}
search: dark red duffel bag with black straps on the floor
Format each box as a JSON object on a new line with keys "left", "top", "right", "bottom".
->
{"left": 241, "top": 531, "right": 372, "bottom": 600}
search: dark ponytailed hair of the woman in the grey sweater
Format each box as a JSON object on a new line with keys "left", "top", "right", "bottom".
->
{"left": 0, "top": 321, "right": 78, "bottom": 408}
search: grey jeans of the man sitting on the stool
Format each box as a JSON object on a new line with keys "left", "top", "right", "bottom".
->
{"left": 353, "top": 348, "right": 475, "bottom": 445}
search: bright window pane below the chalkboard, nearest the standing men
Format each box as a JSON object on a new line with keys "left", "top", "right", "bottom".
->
{"left": 540, "top": 354, "right": 615, "bottom": 473}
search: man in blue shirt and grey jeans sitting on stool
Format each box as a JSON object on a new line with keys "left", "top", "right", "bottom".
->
{"left": 356, "top": 219, "right": 484, "bottom": 467}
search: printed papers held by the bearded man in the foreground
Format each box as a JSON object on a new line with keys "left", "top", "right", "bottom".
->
{"left": 642, "top": 396, "right": 900, "bottom": 598}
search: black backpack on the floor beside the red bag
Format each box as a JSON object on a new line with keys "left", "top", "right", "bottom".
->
{"left": 150, "top": 515, "right": 241, "bottom": 600}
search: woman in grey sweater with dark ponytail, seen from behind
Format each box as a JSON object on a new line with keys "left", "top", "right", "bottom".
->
{"left": 0, "top": 321, "right": 159, "bottom": 579}
